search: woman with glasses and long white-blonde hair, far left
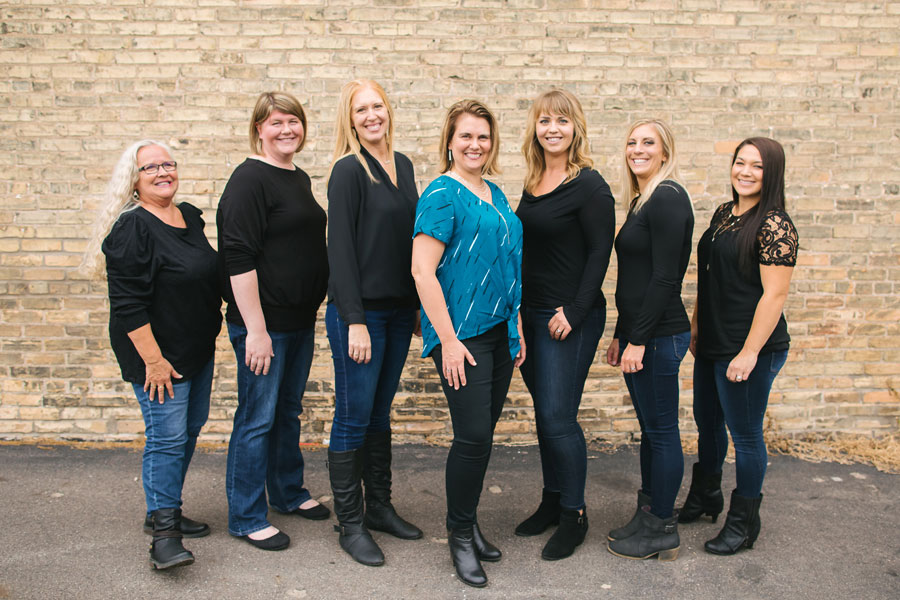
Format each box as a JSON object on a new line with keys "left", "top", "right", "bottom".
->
{"left": 85, "top": 140, "right": 222, "bottom": 569}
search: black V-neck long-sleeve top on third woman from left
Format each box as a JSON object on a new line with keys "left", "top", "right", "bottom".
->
{"left": 328, "top": 148, "right": 419, "bottom": 324}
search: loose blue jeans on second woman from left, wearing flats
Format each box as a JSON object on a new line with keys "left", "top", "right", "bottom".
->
{"left": 225, "top": 323, "right": 315, "bottom": 536}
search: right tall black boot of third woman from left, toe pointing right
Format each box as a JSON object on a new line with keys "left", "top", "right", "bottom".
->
{"left": 363, "top": 430, "right": 422, "bottom": 540}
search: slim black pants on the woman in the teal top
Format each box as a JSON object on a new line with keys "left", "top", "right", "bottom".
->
{"left": 431, "top": 322, "right": 513, "bottom": 529}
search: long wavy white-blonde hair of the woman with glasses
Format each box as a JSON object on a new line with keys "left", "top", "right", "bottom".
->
{"left": 79, "top": 140, "right": 172, "bottom": 278}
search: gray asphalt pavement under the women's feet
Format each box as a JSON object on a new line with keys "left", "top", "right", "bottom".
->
{"left": 0, "top": 445, "right": 900, "bottom": 600}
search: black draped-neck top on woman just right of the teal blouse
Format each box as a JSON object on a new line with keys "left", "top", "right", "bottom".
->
{"left": 516, "top": 169, "right": 616, "bottom": 329}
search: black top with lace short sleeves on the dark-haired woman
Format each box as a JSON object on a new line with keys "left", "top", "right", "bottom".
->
{"left": 697, "top": 201, "right": 799, "bottom": 360}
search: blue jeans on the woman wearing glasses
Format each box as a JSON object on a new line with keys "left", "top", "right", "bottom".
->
{"left": 132, "top": 359, "right": 213, "bottom": 514}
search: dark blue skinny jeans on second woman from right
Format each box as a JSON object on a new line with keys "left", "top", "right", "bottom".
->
{"left": 619, "top": 331, "right": 691, "bottom": 519}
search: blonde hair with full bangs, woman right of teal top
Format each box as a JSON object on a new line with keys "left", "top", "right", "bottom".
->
{"left": 522, "top": 89, "right": 594, "bottom": 193}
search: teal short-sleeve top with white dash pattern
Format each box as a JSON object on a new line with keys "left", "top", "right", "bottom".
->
{"left": 413, "top": 175, "right": 522, "bottom": 357}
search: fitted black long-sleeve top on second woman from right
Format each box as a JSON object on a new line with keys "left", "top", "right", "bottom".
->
{"left": 615, "top": 180, "right": 694, "bottom": 346}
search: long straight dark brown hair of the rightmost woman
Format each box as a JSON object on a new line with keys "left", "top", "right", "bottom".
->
{"left": 731, "top": 137, "right": 785, "bottom": 275}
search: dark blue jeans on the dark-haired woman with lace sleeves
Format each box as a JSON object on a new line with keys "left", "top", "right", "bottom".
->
{"left": 694, "top": 350, "right": 787, "bottom": 498}
